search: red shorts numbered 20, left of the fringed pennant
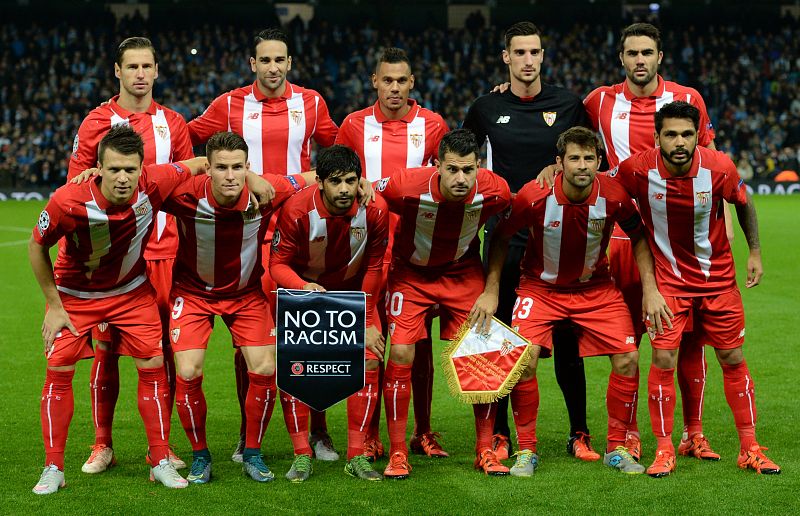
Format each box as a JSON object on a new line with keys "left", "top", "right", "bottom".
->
{"left": 386, "top": 259, "right": 484, "bottom": 345}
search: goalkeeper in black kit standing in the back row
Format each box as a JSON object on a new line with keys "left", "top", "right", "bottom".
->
{"left": 464, "top": 22, "right": 588, "bottom": 460}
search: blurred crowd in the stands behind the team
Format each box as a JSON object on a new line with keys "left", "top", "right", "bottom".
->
{"left": 0, "top": 12, "right": 800, "bottom": 187}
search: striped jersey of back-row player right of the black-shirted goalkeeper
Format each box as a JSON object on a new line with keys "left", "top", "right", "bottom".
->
{"left": 583, "top": 75, "right": 714, "bottom": 169}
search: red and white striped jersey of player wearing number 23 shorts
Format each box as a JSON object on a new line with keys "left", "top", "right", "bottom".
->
{"left": 497, "top": 174, "right": 641, "bottom": 290}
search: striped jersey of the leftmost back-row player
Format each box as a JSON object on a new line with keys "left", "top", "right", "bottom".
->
{"left": 67, "top": 95, "right": 194, "bottom": 260}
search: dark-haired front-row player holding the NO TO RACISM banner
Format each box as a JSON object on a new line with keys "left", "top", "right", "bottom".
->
{"left": 270, "top": 145, "right": 389, "bottom": 482}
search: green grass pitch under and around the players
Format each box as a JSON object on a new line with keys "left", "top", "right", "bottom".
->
{"left": 0, "top": 196, "right": 800, "bottom": 514}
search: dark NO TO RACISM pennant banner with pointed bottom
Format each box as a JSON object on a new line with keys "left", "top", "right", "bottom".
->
{"left": 275, "top": 288, "right": 366, "bottom": 410}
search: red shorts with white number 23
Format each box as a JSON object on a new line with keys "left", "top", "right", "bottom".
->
{"left": 511, "top": 278, "right": 636, "bottom": 357}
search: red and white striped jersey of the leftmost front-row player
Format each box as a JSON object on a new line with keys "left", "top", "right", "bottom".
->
{"left": 33, "top": 163, "right": 191, "bottom": 299}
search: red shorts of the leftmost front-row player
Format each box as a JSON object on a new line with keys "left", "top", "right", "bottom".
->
{"left": 47, "top": 282, "right": 162, "bottom": 367}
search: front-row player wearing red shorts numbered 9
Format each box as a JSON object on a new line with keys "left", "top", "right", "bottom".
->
{"left": 163, "top": 132, "right": 314, "bottom": 484}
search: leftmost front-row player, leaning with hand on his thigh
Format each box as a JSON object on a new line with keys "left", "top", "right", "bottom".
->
{"left": 28, "top": 126, "right": 205, "bottom": 494}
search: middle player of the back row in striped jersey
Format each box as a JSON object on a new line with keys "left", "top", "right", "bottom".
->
{"left": 336, "top": 47, "right": 447, "bottom": 460}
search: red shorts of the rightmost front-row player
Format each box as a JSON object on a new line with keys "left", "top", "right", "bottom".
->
{"left": 650, "top": 288, "right": 744, "bottom": 349}
